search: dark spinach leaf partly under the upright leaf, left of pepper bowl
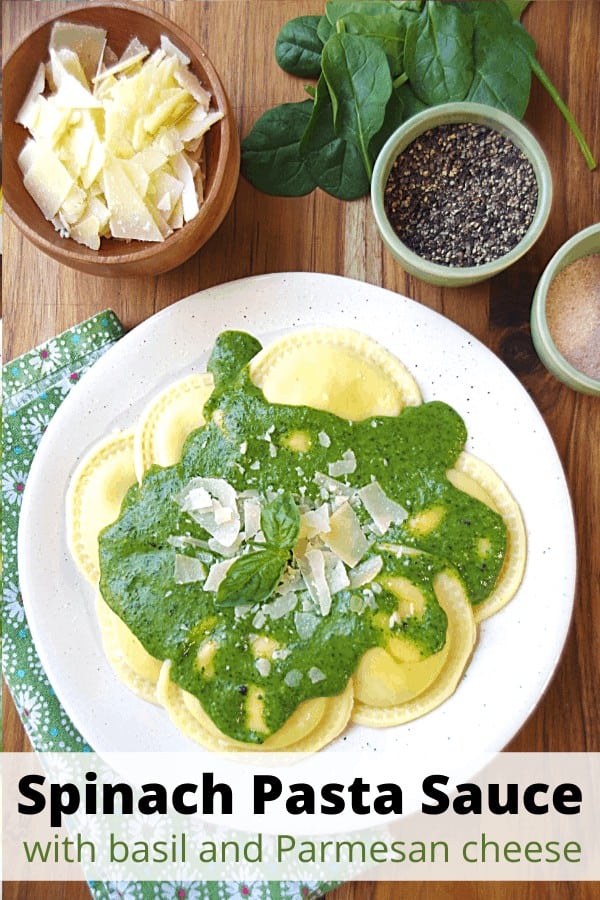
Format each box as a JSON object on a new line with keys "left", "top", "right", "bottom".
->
{"left": 300, "top": 76, "right": 369, "bottom": 200}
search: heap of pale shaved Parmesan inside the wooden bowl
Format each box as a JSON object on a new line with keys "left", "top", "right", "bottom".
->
{"left": 17, "top": 22, "right": 223, "bottom": 249}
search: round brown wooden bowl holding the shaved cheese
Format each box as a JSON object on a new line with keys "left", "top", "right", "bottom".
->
{"left": 3, "top": 2, "right": 240, "bottom": 276}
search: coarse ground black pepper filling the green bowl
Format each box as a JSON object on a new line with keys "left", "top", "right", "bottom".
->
{"left": 384, "top": 123, "right": 538, "bottom": 267}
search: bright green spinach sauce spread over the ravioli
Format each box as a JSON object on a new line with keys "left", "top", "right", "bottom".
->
{"left": 99, "top": 332, "right": 507, "bottom": 743}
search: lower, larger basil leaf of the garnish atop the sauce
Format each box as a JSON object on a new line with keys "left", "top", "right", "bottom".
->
{"left": 217, "top": 548, "right": 288, "bottom": 606}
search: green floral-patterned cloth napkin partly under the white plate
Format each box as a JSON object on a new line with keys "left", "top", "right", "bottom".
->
{"left": 2, "top": 310, "right": 334, "bottom": 900}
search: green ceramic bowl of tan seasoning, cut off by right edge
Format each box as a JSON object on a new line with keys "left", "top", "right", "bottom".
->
{"left": 531, "top": 223, "right": 600, "bottom": 396}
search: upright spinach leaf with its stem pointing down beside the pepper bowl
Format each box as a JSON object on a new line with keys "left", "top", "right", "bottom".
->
{"left": 322, "top": 34, "right": 392, "bottom": 179}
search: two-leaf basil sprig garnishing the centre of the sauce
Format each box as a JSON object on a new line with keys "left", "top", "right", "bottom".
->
{"left": 217, "top": 492, "right": 300, "bottom": 606}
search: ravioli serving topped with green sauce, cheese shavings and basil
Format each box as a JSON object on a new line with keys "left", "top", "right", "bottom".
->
{"left": 68, "top": 329, "right": 525, "bottom": 750}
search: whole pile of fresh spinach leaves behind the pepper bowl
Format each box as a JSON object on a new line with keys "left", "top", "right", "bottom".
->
{"left": 242, "top": 0, "right": 595, "bottom": 200}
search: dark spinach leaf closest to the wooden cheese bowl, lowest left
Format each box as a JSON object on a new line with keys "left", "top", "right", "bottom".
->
{"left": 241, "top": 100, "right": 316, "bottom": 197}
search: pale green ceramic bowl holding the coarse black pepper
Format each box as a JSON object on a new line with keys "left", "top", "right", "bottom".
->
{"left": 371, "top": 103, "right": 552, "bottom": 287}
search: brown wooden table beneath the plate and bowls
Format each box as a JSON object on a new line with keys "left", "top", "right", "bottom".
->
{"left": 3, "top": 0, "right": 600, "bottom": 900}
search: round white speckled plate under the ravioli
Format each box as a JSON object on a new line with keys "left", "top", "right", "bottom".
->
{"left": 19, "top": 273, "right": 575, "bottom": 755}
